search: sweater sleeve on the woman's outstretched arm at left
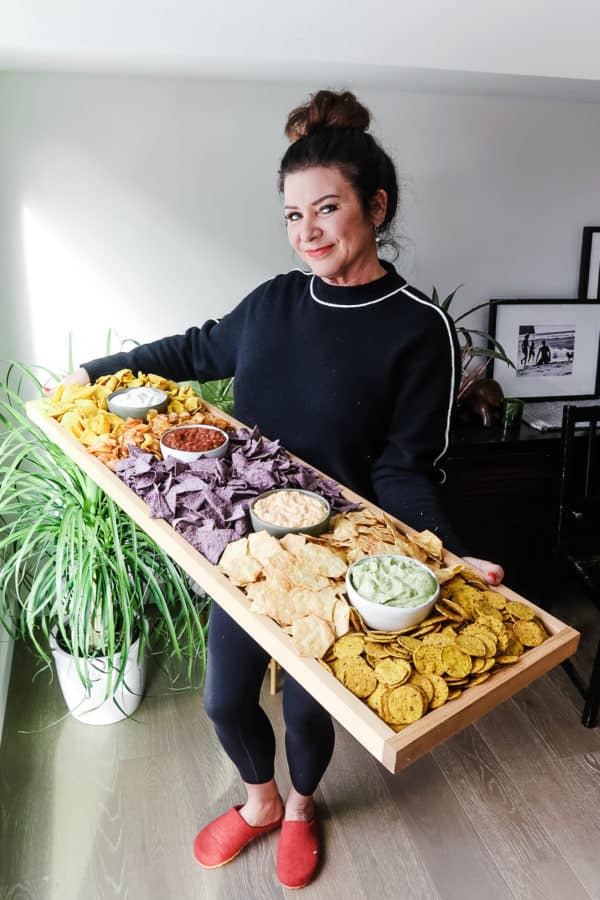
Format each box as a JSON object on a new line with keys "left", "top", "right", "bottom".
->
{"left": 82, "top": 294, "right": 252, "bottom": 382}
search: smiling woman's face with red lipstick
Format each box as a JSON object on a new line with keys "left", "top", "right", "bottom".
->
{"left": 283, "top": 166, "right": 387, "bottom": 285}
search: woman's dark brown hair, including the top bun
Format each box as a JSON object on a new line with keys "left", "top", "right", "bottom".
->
{"left": 279, "top": 91, "right": 398, "bottom": 249}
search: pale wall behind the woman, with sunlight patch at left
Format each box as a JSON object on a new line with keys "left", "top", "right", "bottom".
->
{"left": 0, "top": 74, "right": 600, "bottom": 367}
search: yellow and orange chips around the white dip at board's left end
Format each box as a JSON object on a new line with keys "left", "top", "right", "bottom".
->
{"left": 43, "top": 369, "right": 229, "bottom": 470}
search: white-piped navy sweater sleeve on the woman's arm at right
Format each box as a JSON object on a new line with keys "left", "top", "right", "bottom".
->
{"left": 372, "top": 312, "right": 467, "bottom": 556}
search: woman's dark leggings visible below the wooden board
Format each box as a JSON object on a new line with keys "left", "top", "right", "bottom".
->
{"left": 204, "top": 602, "right": 334, "bottom": 796}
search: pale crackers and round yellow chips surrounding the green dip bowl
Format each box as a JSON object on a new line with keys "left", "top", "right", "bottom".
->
{"left": 220, "top": 509, "right": 548, "bottom": 731}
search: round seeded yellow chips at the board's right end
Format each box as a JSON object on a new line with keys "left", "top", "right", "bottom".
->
{"left": 320, "top": 569, "right": 548, "bottom": 731}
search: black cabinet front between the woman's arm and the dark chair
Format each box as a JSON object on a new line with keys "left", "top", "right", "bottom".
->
{"left": 443, "top": 425, "right": 560, "bottom": 606}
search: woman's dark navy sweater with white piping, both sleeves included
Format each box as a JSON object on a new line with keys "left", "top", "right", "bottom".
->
{"left": 83, "top": 263, "right": 465, "bottom": 555}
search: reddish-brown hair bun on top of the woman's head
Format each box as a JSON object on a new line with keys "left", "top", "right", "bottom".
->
{"left": 285, "top": 91, "right": 371, "bottom": 141}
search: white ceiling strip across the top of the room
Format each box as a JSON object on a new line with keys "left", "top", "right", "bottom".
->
{"left": 0, "top": 0, "right": 600, "bottom": 102}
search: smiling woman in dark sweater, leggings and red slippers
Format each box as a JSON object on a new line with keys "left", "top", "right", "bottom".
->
{"left": 64, "top": 91, "right": 502, "bottom": 887}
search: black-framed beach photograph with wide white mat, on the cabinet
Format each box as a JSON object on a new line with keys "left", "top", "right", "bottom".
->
{"left": 489, "top": 300, "right": 600, "bottom": 400}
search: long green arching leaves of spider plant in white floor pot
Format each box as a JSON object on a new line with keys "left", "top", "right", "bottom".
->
{"left": 0, "top": 364, "right": 209, "bottom": 696}
